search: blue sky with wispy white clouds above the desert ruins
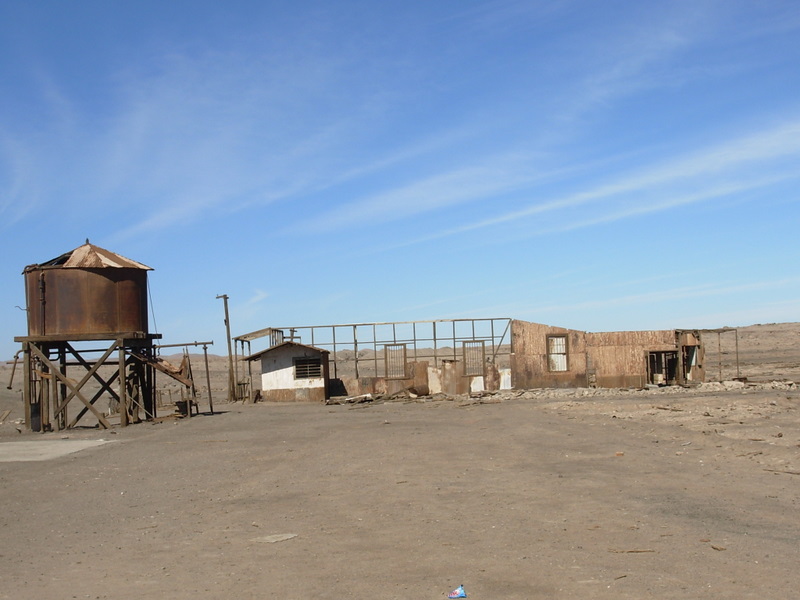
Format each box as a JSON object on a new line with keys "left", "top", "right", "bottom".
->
{"left": 0, "top": 0, "right": 800, "bottom": 358}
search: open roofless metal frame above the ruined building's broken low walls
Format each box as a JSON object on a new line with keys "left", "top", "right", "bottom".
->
{"left": 234, "top": 317, "right": 513, "bottom": 379}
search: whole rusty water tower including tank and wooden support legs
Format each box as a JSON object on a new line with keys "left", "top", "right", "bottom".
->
{"left": 15, "top": 240, "right": 161, "bottom": 431}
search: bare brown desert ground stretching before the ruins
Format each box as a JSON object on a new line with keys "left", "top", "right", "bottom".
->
{"left": 0, "top": 323, "right": 800, "bottom": 600}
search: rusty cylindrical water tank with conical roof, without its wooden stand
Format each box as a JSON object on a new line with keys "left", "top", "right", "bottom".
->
{"left": 23, "top": 240, "right": 152, "bottom": 339}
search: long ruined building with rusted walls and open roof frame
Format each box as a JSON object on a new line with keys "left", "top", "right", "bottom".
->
{"left": 235, "top": 318, "right": 705, "bottom": 401}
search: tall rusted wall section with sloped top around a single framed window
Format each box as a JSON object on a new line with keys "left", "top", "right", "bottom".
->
{"left": 511, "top": 320, "right": 587, "bottom": 389}
